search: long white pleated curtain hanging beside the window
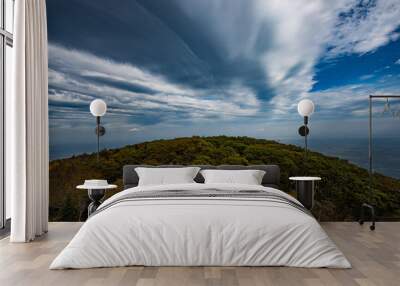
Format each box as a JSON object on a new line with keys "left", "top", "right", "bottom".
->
{"left": 6, "top": 0, "right": 49, "bottom": 242}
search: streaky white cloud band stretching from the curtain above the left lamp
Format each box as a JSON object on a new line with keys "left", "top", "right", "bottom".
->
{"left": 49, "top": 44, "right": 260, "bottom": 127}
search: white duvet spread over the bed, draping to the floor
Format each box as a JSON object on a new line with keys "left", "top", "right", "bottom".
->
{"left": 50, "top": 183, "right": 351, "bottom": 269}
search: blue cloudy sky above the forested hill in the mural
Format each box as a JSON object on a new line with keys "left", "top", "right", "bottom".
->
{"left": 47, "top": 0, "right": 400, "bottom": 159}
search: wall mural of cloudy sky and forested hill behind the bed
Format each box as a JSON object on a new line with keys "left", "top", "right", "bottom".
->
{"left": 47, "top": 0, "right": 400, "bottom": 220}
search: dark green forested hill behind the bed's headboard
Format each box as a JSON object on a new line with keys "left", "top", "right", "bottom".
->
{"left": 49, "top": 136, "right": 400, "bottom": 221}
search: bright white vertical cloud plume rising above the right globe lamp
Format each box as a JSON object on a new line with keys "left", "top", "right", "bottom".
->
{"left": 253, "top": 0, "right": 346, "bottom": 113}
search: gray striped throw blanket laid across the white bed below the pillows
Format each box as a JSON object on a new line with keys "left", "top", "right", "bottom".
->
{"left": 90, "top": 189, "right": 312, "bottom": 217}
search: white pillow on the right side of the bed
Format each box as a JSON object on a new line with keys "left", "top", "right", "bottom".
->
{"left": 200, "top": 170, "right": 265, "bottom": 185}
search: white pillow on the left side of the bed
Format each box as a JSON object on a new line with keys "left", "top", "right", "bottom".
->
{"left": 135, "top": 167, "right": 200, "bottom": 186}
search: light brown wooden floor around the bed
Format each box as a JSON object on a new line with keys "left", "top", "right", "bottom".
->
{"left": 0, "top": 222, "right": 400, "bottom": 286}
